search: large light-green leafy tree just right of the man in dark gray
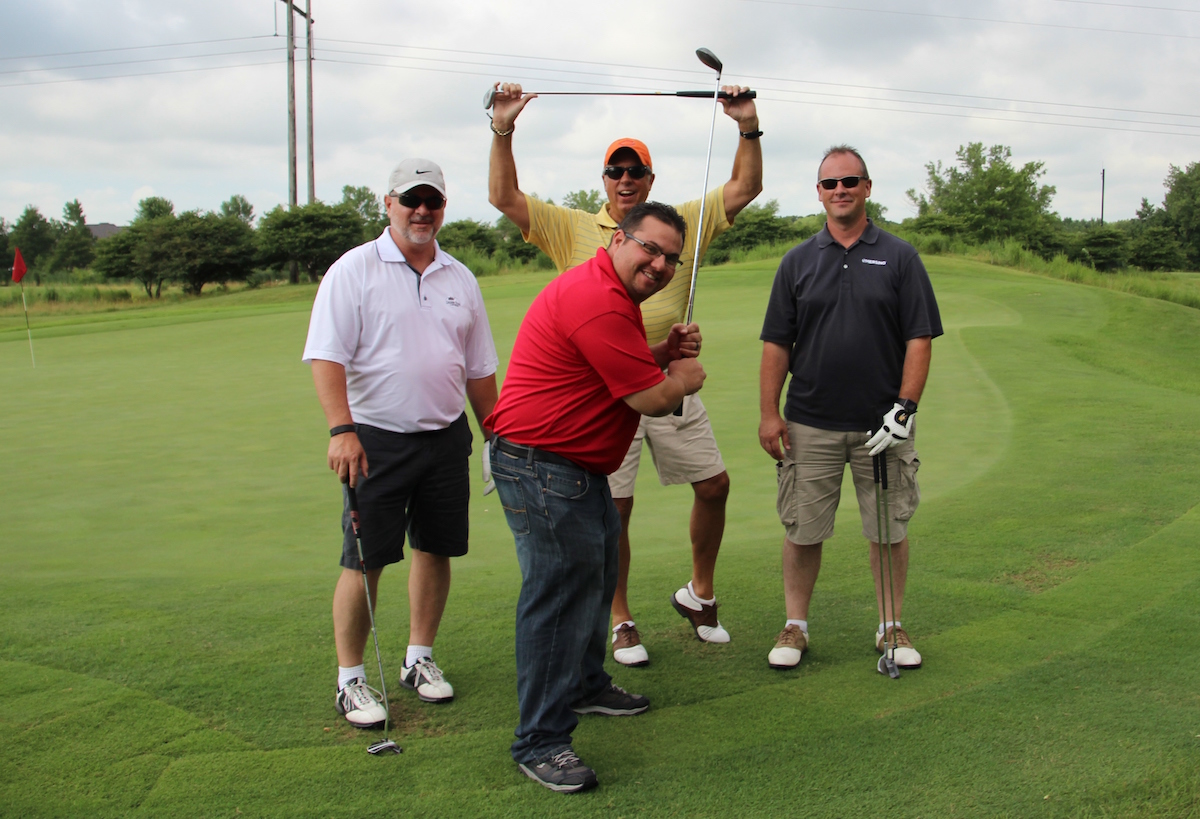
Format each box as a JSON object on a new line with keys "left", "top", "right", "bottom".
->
{"left": 908, "top": 142, "right": 1055, "bottom": 250}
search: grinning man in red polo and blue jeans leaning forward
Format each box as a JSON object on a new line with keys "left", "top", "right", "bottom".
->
{"left": 484, "top": 202, "right": 704, "bottom": 793}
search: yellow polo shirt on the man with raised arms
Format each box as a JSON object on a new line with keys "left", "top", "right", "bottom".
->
{"left": 524, "top": 185, "right": 730, "bottom": 345}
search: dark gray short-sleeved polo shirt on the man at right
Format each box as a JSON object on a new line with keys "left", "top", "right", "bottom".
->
{"left": 760, "top": 222, "right": 942, "bottom": 432}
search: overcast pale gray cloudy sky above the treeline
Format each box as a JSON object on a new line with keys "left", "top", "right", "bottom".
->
{"left": 0, "top": 0, "right": 1200, "bottom": 229}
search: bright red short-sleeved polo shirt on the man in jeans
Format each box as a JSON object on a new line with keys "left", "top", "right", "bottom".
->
{"left": 485, "top": 249, "right": 666, "bottom": 474}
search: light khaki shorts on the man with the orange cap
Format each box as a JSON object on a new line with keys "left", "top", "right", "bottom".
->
{"left": 608, "top": 395, "right": 725, "bottom": 497}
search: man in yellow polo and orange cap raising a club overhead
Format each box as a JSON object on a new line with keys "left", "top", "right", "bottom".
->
{"left": 488, "top": 83, "right": 762, "bottom": 665}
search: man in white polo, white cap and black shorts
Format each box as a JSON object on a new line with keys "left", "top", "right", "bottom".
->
{"left": 304, "top": 159, "right": 497, "bottom": 728}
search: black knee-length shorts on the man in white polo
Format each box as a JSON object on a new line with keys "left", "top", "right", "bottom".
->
{"left": 342, "top": 413, "right": 472, "bottom": 569}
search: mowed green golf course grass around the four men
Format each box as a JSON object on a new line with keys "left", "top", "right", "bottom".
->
{"left": 0, "top": 258, "right": 1200, "bottom": 818}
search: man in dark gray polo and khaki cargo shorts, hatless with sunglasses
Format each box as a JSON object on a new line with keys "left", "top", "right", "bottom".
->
{"left": 758, "top": 145, "right": 942, "bottom": 669}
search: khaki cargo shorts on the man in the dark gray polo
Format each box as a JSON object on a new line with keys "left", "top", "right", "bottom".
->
{"left": 776, "top": 422, "right": 920, "bottom": 545}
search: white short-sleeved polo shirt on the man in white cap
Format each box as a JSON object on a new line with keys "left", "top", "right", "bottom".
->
{"left": 304, "top": 228, "right": 498, "bottom": 432}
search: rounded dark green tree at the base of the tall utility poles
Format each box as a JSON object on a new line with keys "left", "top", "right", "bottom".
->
{"left": 257, "top": 202, "right": 362, "bottom": 283}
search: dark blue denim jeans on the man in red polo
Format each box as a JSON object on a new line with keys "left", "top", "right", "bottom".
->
{"left": 492, "top": 446, "right": 620, "bottom": 763}
